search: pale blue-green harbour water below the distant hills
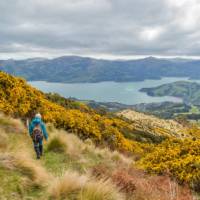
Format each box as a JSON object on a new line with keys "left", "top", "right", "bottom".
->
{"left": 29, "top": 77, "right": 191, "bottom": 105}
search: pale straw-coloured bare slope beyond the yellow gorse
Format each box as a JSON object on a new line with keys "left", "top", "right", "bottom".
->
{"left": 118, "top": 110, "right": 189, "bottom": 138}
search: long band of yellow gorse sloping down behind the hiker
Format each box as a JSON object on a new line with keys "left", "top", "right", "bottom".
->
{"left": 0, "top": 72, "right": 157, "bottom": 153}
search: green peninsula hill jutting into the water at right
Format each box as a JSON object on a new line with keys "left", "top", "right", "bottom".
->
{"left": 140, "top": 81, "right": 200, "bottom": 106}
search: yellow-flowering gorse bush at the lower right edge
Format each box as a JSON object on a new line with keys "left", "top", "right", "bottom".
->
{"left": 138, "top": 139, "right": 200, "bottom": 189}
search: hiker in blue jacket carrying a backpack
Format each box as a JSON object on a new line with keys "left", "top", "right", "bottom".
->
{"left": 29, "top": 113, "right": 48, "bottom": 159}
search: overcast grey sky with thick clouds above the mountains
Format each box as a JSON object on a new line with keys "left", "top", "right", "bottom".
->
{"left": 0, "top": 0, "right": 200, "bottom": 58}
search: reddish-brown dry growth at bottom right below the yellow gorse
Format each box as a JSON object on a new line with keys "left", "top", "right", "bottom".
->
{"left": 126, "top": 168, "right": 193, "bottom": 200}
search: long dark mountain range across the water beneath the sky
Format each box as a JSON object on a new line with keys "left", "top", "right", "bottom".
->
{"left": 0, "top": 56, "right": 200, "bottom": 83}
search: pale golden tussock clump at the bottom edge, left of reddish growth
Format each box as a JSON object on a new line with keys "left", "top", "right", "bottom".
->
{"left": 49, "top": 171, "right": 124, "bottom": 200}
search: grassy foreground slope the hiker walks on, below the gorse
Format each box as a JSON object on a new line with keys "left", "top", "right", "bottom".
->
{"left": 0, "top": 115, "right": 195, "bottom": 200}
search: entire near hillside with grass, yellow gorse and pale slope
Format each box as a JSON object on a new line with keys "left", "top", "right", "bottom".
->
{"left": 0, "top": 72, "right": 200, "bottom": 200}
